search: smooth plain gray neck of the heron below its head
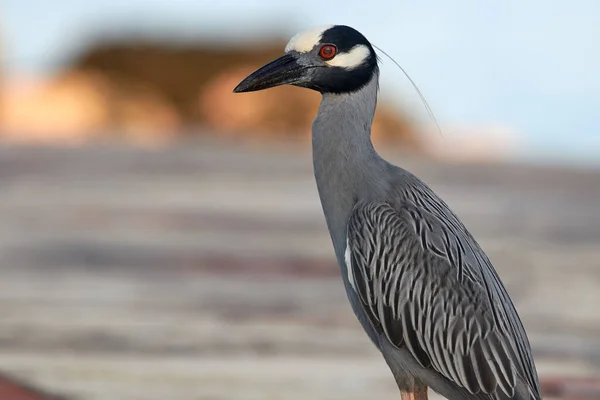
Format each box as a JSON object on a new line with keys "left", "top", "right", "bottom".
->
{"left": 312, "top": 72, "right": 387, "bottom": 261}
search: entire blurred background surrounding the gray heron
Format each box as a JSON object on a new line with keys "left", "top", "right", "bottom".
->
{"left": 0, "top": 0, "right": 600, "bottom": 400}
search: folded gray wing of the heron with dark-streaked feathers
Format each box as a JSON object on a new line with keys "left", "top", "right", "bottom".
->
{"left": 348, "top": 202, "right": 541, "bottom": 399}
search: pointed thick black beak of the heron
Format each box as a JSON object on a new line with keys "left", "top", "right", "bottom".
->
{"left": 233, "top": 54, "right": 306, "bottom": 93}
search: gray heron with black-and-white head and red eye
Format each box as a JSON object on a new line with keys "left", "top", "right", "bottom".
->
{"left": 233, "top": 25, "right": 541, "bottom": 400}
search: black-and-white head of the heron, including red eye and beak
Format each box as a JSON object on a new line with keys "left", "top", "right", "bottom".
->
{"left": 233, "top": 25, "right": 377, "bottom": 93}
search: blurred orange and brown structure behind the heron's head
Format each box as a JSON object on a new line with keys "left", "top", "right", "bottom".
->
{"left": 0, "top": 42, "right": 419, "bottom": 150}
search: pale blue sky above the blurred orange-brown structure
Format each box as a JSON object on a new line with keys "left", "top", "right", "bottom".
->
{"left": 0, "top": 0, "right": 600, "bottom": 164}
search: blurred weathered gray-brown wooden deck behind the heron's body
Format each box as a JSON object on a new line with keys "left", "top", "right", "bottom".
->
{"left": 0, "top": 143, "right": 600, "bottom": 400}
